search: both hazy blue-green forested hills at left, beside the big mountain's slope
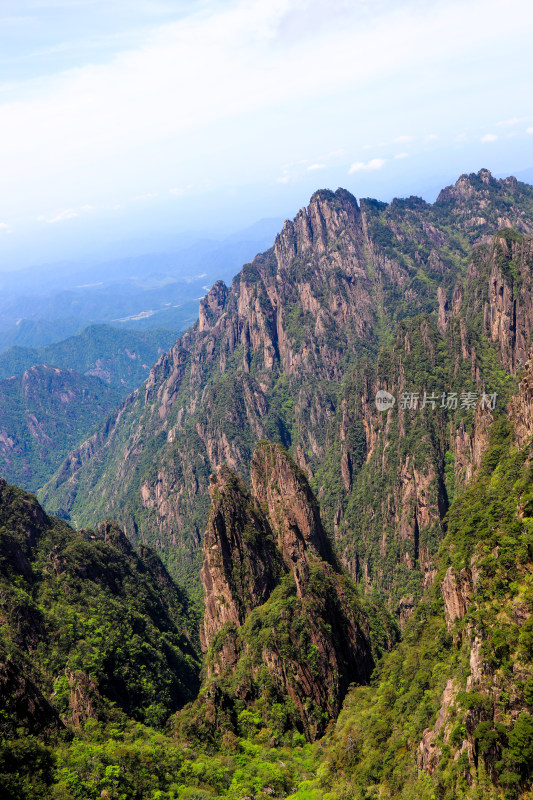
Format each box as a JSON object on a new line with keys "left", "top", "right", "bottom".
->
{"left": 0, "top": 325, "right": 176, "bottom": 491}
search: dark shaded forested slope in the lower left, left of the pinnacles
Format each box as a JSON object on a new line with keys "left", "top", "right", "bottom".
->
{"left": 0, "top": 480, "right": 199, "bottom": 736}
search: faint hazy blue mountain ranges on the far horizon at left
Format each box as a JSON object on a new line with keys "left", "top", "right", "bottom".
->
{"left": 0, "top": 220, "right": 277, "bottom": 352}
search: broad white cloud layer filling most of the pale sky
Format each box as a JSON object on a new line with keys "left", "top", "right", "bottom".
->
{"left": 0, "top": 0, "right": 533, "bottom": 248}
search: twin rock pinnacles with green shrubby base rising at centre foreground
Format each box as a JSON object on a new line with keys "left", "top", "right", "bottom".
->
{"left": 193, "top": 443, "right": 384, "bottom": 739}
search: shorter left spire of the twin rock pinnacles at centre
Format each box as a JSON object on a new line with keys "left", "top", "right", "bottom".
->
{"left": 201, "top": 466, "right": 283, "bottom": 650}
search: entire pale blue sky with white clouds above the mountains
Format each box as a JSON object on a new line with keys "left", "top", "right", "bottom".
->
{"left": 0, "top": 0, "right": 533, "bottom": 269}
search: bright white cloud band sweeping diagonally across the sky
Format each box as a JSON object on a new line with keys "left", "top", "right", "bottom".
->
{"left": 0, "top": 0, "right": 530, "bottom": 220}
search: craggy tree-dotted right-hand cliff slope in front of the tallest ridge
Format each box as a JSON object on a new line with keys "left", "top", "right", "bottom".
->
{"left": 316, "top": 225, "right": 533, "bottom": 613}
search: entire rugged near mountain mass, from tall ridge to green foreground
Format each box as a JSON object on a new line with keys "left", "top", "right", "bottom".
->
{"left": 0, "top": 170, "right": 533, "bottom": 800}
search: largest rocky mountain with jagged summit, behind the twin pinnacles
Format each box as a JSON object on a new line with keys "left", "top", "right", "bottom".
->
{"left": 41, "top": 170, "right": 533, "bottom": 608}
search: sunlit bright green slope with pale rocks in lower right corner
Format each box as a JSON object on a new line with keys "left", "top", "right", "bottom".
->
{"left": 293, "top": 362, "right": 533, "bottom": 800}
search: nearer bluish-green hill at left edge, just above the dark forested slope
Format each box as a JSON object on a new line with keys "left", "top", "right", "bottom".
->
{"left": 0, "top": 364, "right": 122, "bottom": 491}
